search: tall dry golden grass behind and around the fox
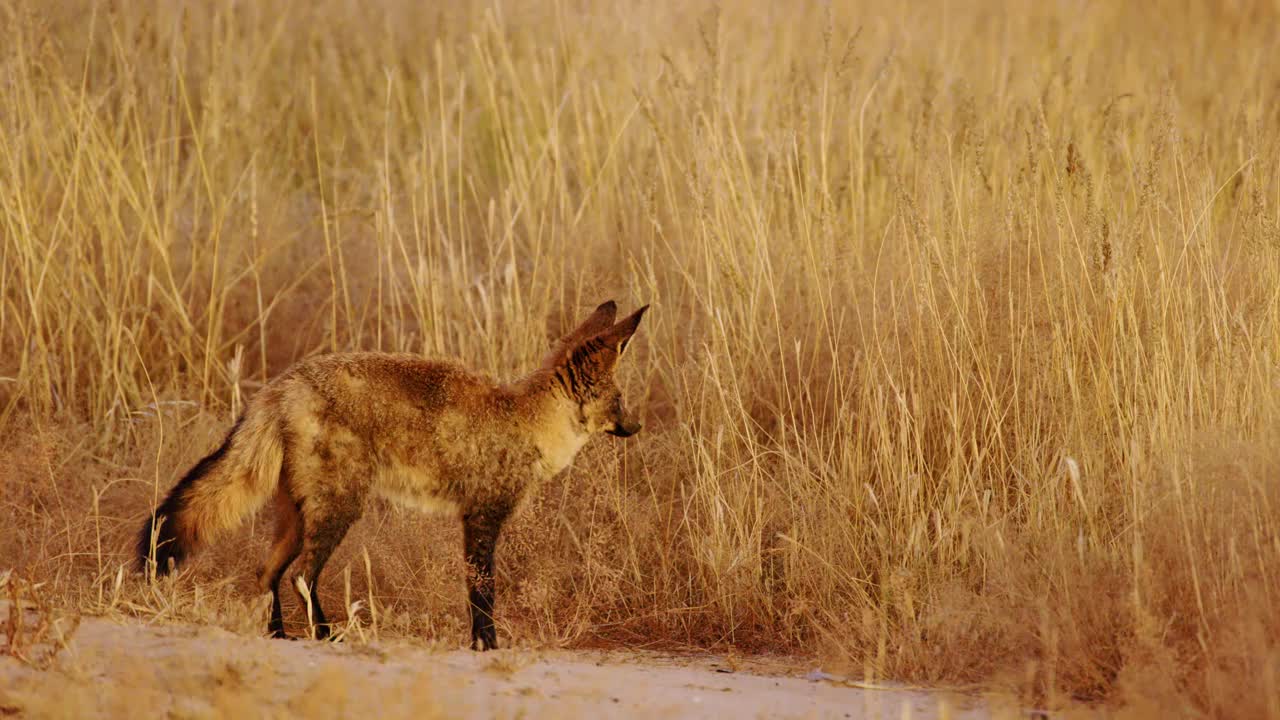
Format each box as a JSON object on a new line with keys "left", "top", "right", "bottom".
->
{"left": 0, "top": 0, "right": 1280, "bottom": 717}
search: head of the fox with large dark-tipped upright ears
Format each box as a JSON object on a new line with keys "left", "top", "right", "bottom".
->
{"left": 543, "top": 300, "right": 649, "bottom": 437}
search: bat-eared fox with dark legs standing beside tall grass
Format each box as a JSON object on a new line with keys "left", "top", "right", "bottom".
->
{"left": 137, "top": 300, "right": 649, "bottom": 651}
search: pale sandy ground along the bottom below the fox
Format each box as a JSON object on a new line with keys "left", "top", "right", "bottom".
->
{"left": 0, "top": 609, "right": 1008, "bottom": 719}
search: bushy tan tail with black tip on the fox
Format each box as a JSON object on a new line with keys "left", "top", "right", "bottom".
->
{"left": 137, "top": 409, "right": 284, "bottom": 575}
